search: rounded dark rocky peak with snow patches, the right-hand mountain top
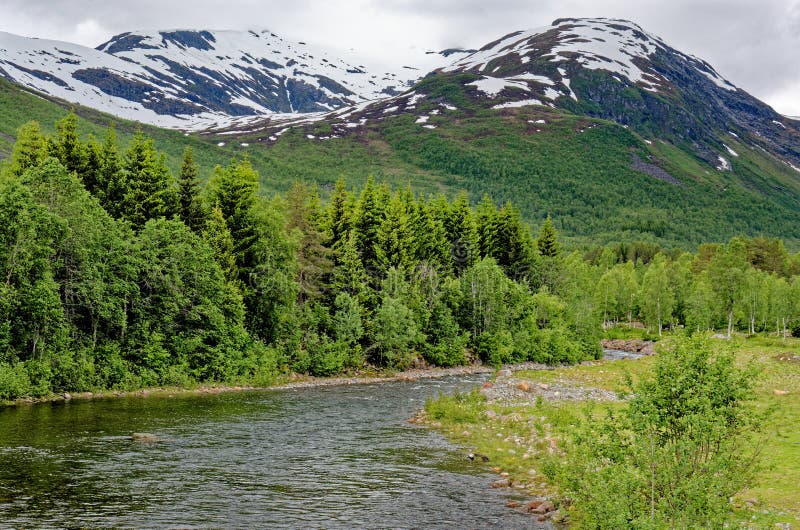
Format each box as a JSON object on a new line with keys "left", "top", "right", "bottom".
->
{"left": 432, "top": 19, "right": 800, "bottom": 168}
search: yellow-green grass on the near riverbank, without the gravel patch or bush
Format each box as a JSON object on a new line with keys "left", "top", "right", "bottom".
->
{"left": 426, "top": 336, "right": 800, "bottom": 528}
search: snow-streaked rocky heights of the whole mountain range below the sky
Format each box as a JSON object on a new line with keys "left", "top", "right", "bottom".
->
{"left": 0, "top": 19, "right": 800, "bottom": 169}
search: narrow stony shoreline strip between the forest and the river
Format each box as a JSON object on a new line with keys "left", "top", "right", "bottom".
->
{"left": 0, "top": 363, "right": 555, "bottom": 407}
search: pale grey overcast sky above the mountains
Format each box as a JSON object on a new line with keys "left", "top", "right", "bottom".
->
{"left": 0, "top": 0, "right": 800, "bottom": 116}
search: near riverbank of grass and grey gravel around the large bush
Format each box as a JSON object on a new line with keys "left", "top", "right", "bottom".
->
{"left": 418, "top": 337, "right": 800, "bottom": 528}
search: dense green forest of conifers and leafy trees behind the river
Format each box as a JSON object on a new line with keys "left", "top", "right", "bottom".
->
{"left": 0, "top": 114, "right": 800, "bottom": 400}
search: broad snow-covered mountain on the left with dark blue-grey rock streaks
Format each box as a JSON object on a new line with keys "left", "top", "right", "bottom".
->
{"left": 0, "top": 30, "right": 462, "bottom": 129}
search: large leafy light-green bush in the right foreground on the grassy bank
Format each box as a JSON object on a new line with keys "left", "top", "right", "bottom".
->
{"left": 546, "top": 336, "right": 760, "bottom": 528}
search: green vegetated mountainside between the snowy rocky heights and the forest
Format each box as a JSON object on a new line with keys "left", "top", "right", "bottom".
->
{"left": 0, "top": 76, "right": 800, "bottom": 249}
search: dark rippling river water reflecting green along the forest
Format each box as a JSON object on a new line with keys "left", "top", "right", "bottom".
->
{"left": 0, "top": 376, "right": 548, "bottom": 528}
